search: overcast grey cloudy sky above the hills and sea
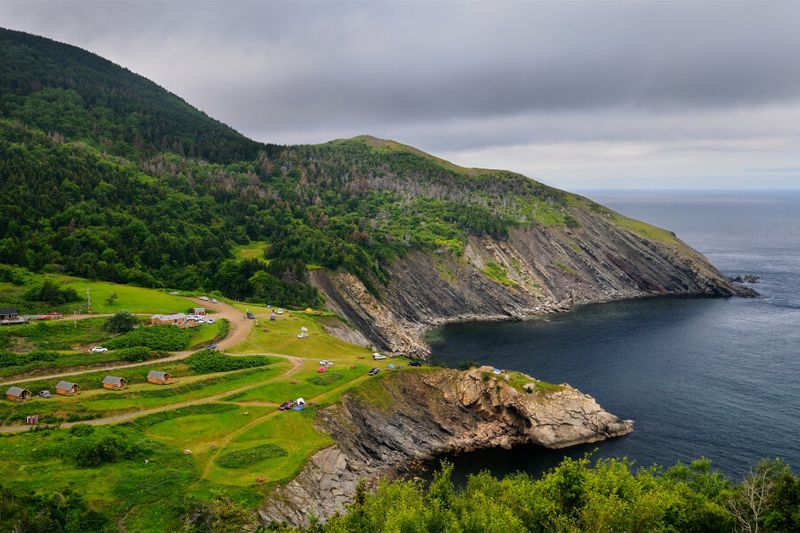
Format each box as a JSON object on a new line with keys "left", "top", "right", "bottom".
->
{"left": 0, "top": 1, "right": 800, "bottom": 191}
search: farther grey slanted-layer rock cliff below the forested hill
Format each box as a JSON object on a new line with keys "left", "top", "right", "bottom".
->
{"left": 312, "top": 201, "right": 754, "bottom": 356}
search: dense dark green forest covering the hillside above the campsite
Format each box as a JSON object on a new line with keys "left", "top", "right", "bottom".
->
{"left": 0, "top": 26, "right": 582, "bottom": 306}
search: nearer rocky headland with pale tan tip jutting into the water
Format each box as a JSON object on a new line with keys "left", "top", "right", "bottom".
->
{"left": 259, "top": 367, "right": 633, "bottom": 525}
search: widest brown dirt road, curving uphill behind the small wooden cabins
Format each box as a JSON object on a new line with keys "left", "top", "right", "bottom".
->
{"left": 0, "top": 298, "right": 255, "bottom": 387}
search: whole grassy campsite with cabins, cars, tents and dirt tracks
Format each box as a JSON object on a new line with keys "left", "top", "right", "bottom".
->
{"left": 0, "top": 268, "right": 412, "bottom": 531}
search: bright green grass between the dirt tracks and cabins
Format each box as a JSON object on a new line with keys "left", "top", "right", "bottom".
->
{"left": 0, "top": 278, "right": 424, "bottom": 532}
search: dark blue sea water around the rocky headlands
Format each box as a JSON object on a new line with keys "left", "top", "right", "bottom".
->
{"left": 430, "top": 193, "right": 800, "bottom": 478}
